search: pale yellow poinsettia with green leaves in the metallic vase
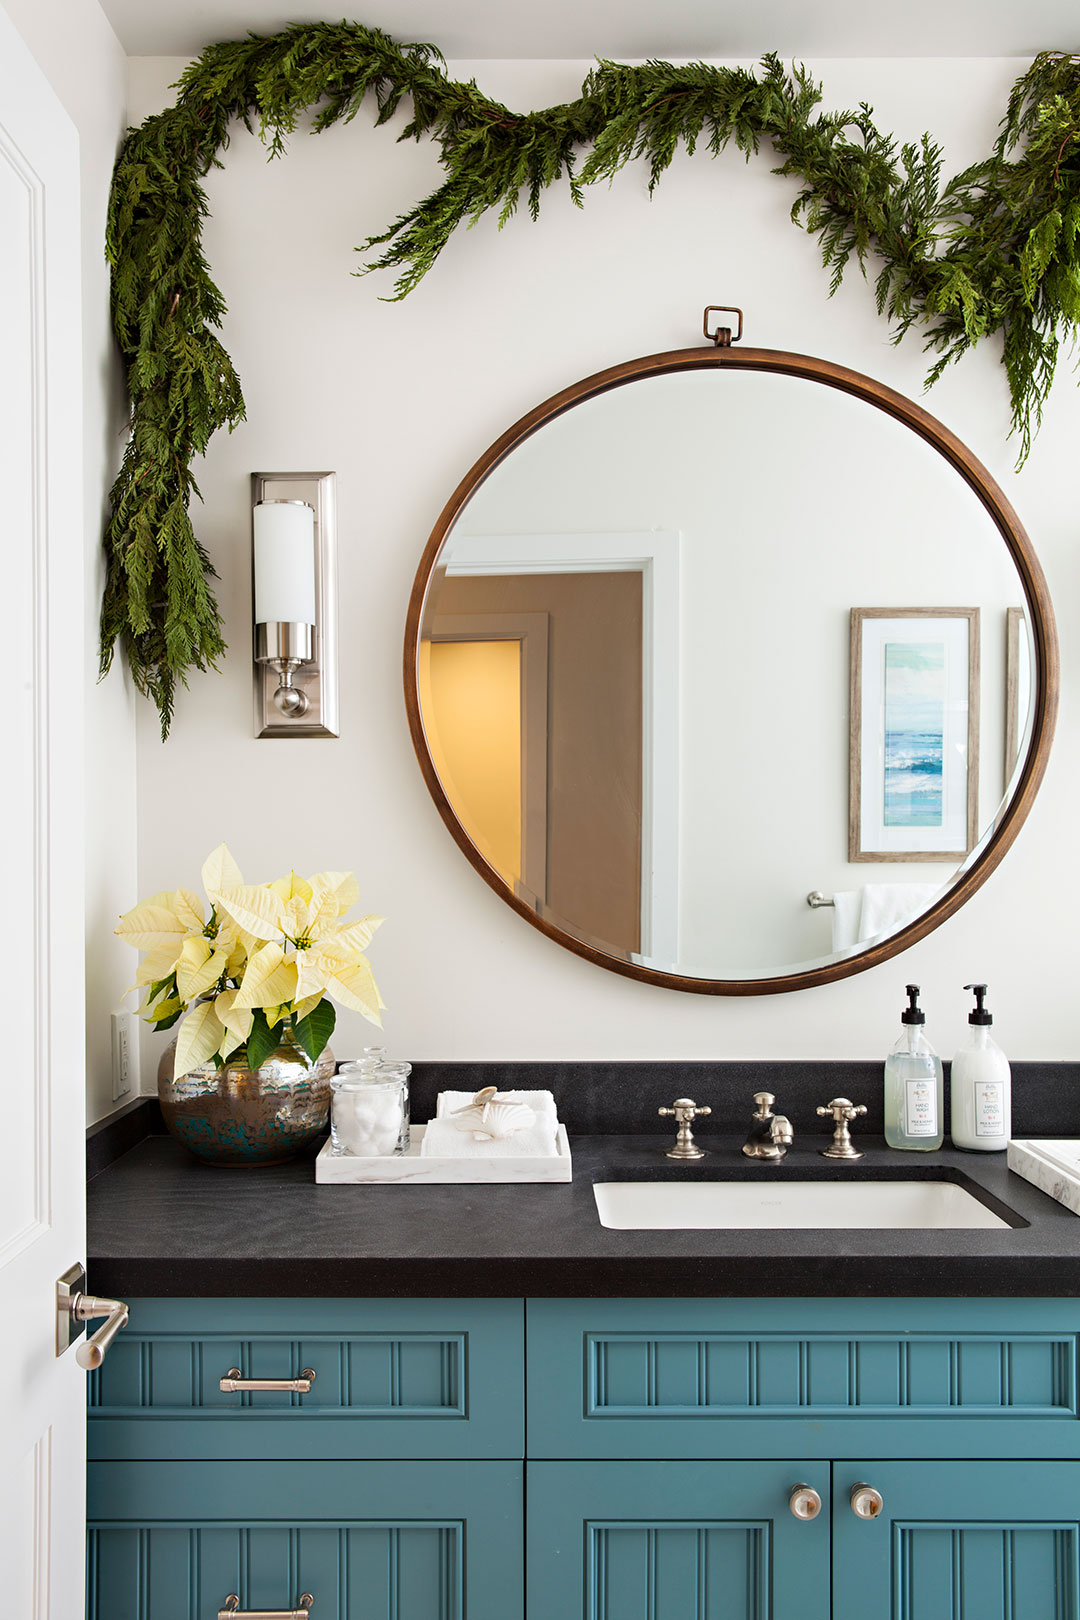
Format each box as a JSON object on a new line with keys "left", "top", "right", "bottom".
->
{"left": 115, "top": 844, "right": 385, "bottom": 1076}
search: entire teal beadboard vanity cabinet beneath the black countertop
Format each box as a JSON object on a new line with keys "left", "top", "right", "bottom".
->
{"left": 87, "top": 1299, "right": 1080, "bottom": 1620}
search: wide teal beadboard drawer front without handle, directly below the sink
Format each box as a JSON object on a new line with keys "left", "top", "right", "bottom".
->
{"left": 526, "top": 1299, "right": 1080, "bottom": 1458}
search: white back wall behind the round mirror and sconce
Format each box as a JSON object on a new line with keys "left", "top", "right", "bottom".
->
{"left": 130, "top": 57, "right": 1080, "bottom": 1082}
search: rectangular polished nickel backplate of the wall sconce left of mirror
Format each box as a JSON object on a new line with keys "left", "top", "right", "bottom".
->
{"left": 251, "top": 473, "right": 340, "bottom": 737}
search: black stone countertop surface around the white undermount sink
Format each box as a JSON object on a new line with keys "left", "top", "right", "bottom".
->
{"left": 87, "top": 1121, "right": 1080, "bottom": 1298}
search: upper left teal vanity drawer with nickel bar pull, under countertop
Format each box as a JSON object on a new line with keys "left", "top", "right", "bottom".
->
{"left": 89, "top": 1299, "right": 525, "bottom": 1460}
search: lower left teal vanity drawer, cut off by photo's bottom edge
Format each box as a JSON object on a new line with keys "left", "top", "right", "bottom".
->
{"left": 86, "top": 1463, "right": 521, "bottom": 1620}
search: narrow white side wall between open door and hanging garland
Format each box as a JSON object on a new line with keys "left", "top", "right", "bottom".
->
{"left": 3, "top": 0, "right": 136, "bottom": 1123}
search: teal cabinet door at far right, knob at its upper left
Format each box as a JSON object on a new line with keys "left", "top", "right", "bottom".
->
{"left": 832, "top": 1461, "right": 1080, "bottom": 1620}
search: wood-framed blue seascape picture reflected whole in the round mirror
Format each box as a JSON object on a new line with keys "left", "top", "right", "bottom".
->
{"left": 848, "top": 608, "right": 980, "bottom": 862}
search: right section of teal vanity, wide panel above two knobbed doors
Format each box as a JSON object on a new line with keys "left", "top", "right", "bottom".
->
{"left": 526, "top": 1299, "right": 1080, "bottom": 1620}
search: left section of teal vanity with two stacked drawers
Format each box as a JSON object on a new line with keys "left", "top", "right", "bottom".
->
{"left": 87, "top": 1299, "right": 523, "bottom": 1620}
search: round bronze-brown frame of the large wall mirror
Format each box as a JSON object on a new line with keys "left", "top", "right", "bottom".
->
{"left": 403, "top": 345, "right": 1059, "bottom": 996}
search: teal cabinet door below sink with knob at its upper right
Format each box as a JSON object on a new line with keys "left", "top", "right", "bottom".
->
{"left": 525, "top": 1461, "right": 829, "bottom": 1620}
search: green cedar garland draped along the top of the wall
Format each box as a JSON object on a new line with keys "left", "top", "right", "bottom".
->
{"left": 100, "top": 23, "right": 1080, "bottom": 737}
